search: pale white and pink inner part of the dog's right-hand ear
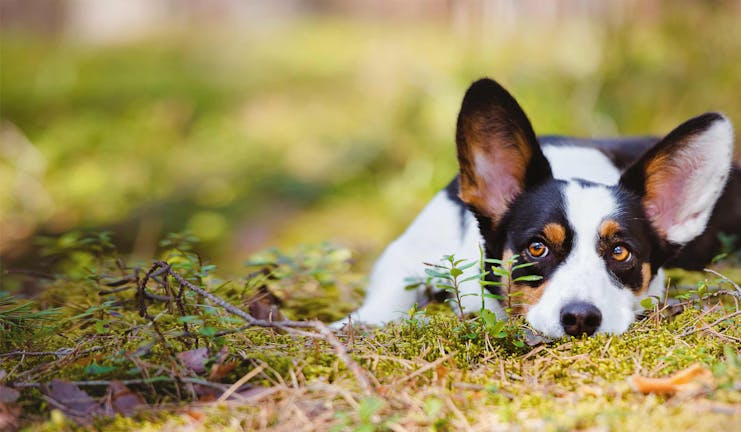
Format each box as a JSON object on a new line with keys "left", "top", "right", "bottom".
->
{"left": 662, "top": 117, "right": 733, "bottom": 244}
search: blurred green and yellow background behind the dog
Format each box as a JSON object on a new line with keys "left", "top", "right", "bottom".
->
{"left": 0, "top": 0, "right": 741, "bottom": 280}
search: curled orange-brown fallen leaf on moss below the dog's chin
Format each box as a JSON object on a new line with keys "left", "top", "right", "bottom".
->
{"left": 628, "top": 363, "right": 715, "bottom": 394}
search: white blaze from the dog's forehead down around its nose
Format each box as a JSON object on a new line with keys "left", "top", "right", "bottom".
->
{"left": 527, "top": 182, "right": 636, "bottom": 337}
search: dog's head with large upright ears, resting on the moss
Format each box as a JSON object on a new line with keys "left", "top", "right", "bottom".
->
{"left": 456, "top": 79, "right": 733, "bottom": 337}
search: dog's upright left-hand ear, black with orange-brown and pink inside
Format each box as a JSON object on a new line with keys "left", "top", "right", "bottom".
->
{"left": 456, "top": 79, "right": 552, "bottom": 223}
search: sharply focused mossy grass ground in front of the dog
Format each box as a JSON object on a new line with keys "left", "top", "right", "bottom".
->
{"left": 0, "top": 235, "right": 741, "bottom": 431}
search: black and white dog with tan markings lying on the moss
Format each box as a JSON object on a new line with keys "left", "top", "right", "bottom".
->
{"left": 336, "top": 79, "right": 738, "bottom": 337}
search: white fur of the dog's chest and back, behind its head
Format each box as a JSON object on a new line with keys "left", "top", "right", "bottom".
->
{"left": 333, "top": 146, "right": 636, "bottom": 327}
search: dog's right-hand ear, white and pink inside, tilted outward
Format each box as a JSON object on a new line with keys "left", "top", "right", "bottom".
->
{"left": 620, "top": 113, "right": 733, "bottom": 245}
